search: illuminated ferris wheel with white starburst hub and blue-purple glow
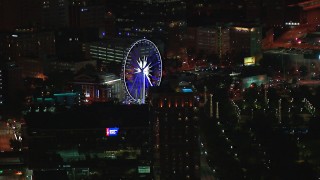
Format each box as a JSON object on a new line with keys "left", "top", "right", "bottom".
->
{"left": 122, "top": 39, "right": 162, "bottom": 104}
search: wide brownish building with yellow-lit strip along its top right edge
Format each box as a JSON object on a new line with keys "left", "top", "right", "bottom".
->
{"left": 189, "top": 24, "right": 262, "bottom": 63}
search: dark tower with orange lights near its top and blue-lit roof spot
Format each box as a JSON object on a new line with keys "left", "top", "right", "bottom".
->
{"left": 150, "top": 86, "right": 200, "bottom": 179}
